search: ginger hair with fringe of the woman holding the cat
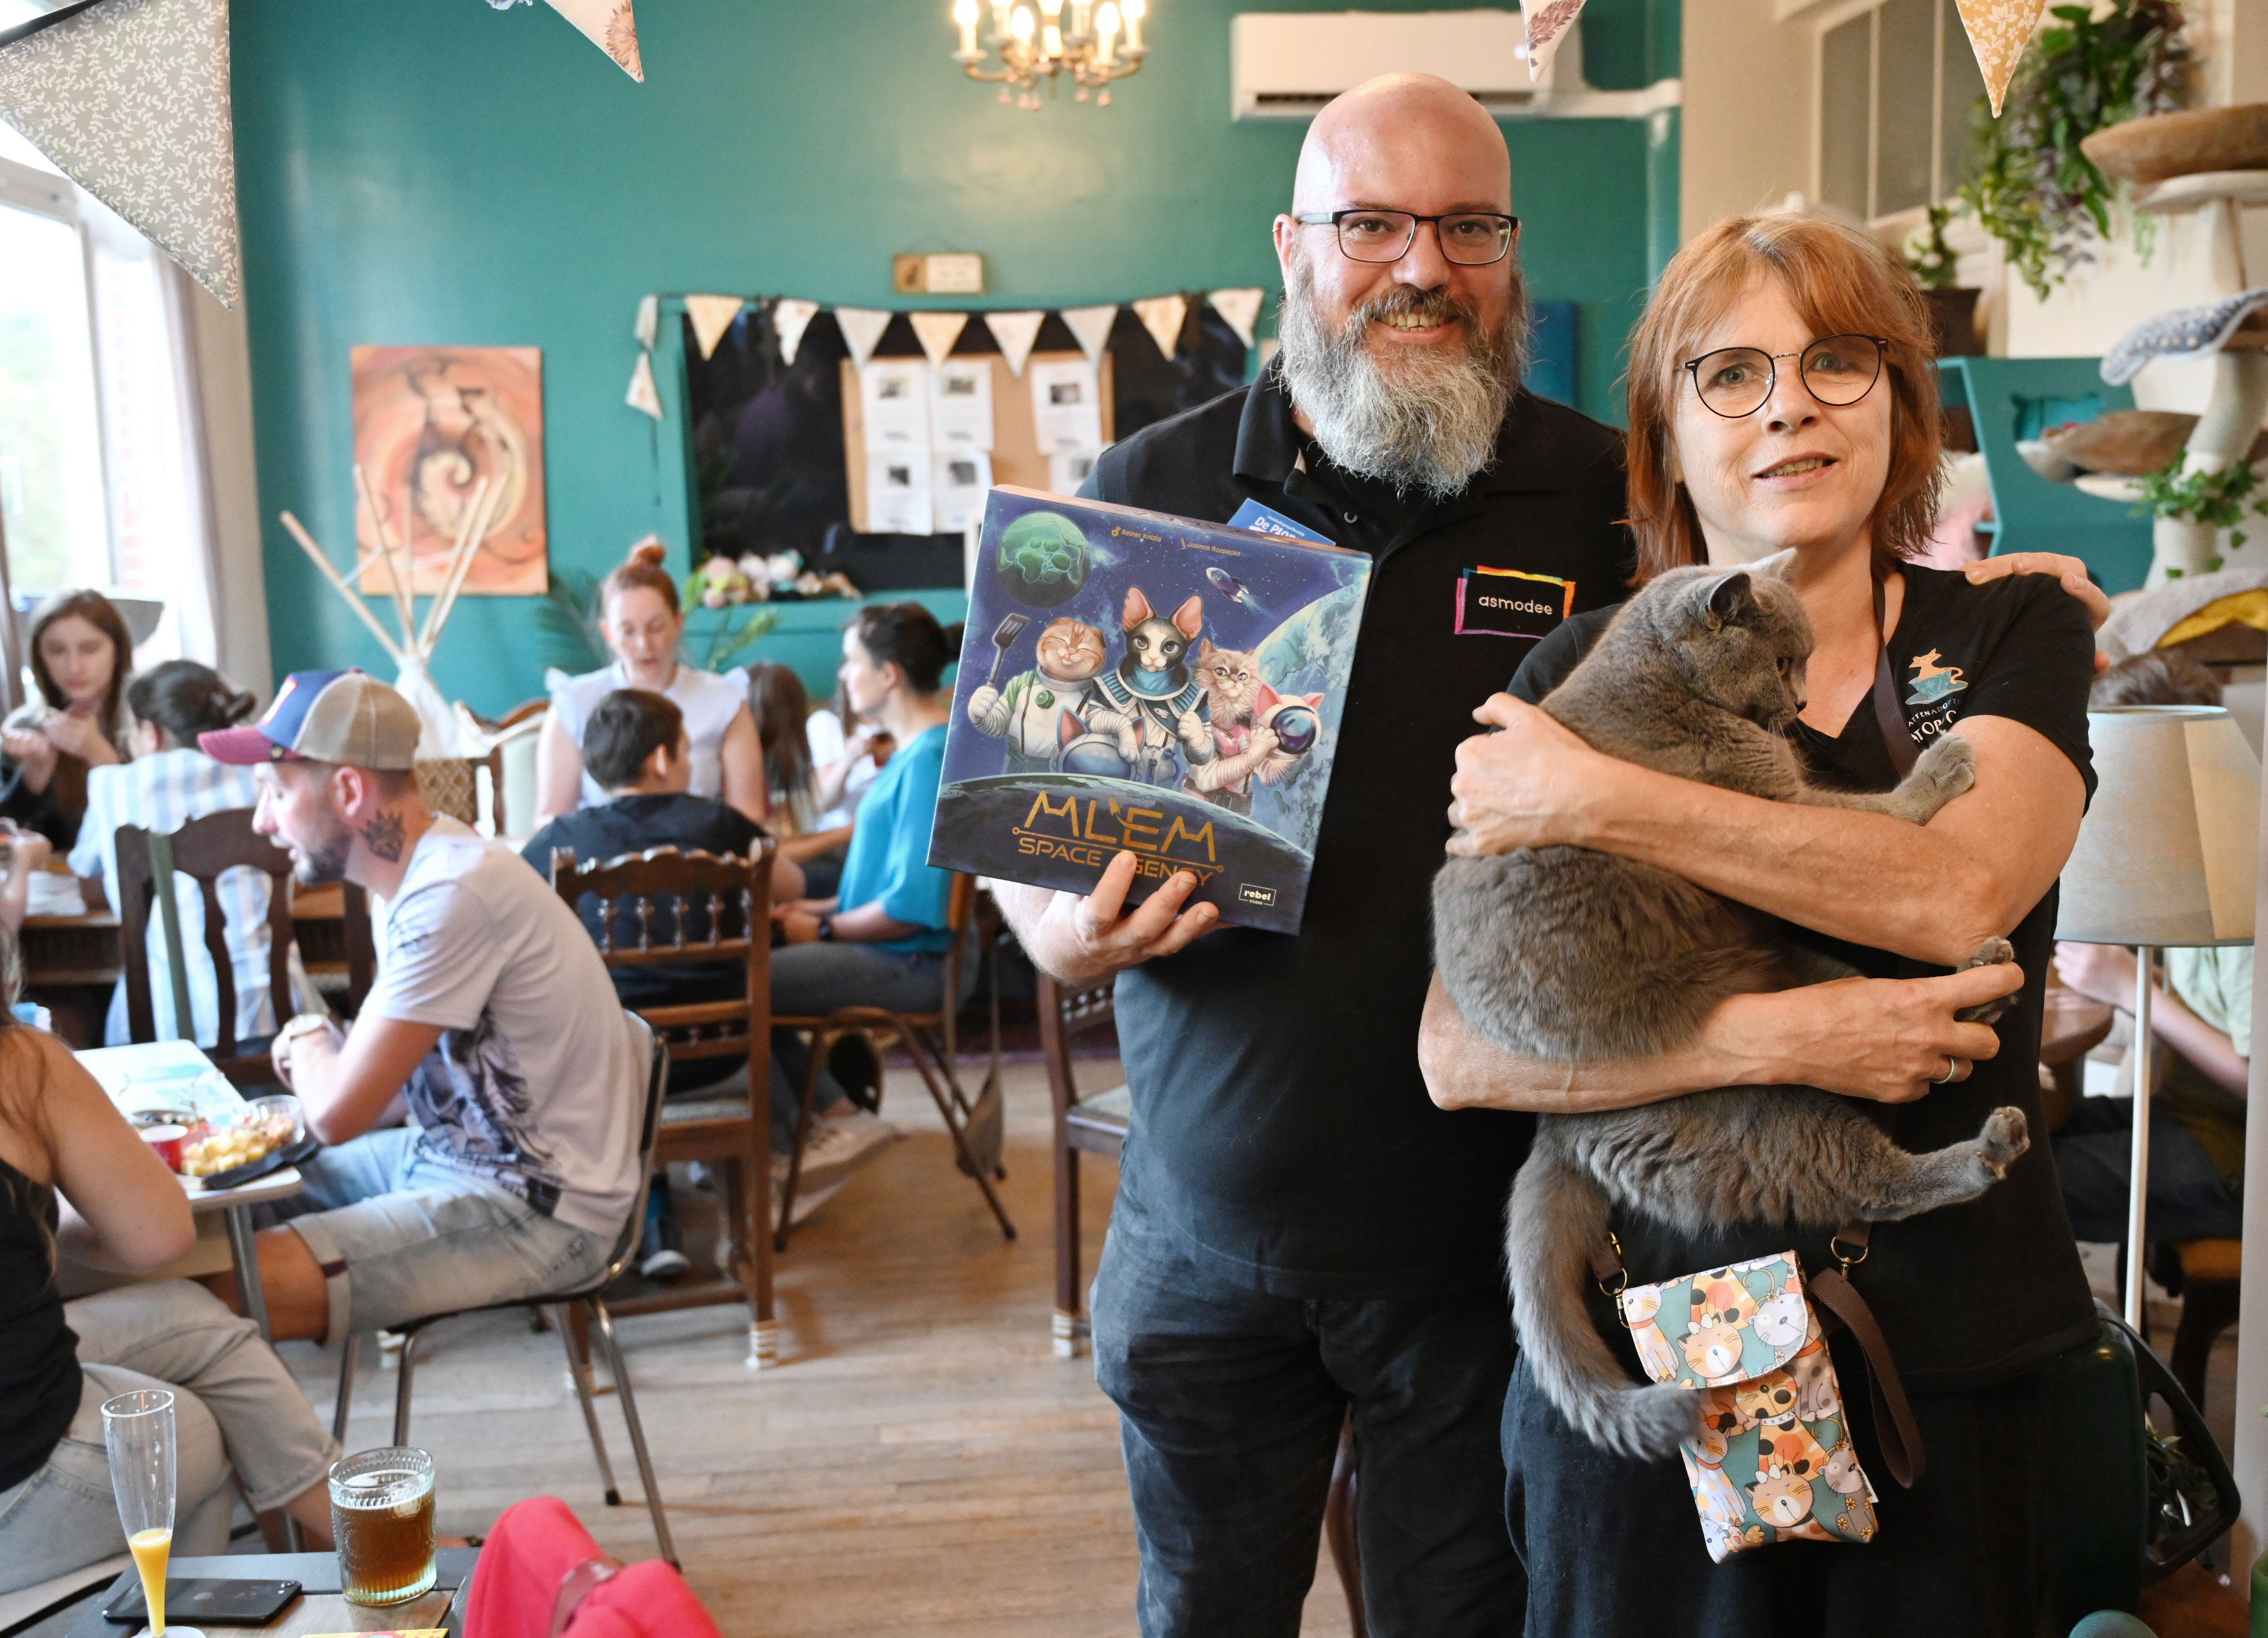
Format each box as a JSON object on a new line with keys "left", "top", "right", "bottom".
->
{"left": 1629, "top": 213, "right": 1941, "bottom": 583}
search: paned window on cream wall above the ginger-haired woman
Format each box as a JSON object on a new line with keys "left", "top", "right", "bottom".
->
{"left": 1812, "top": 0, "right": 1984, "bottom": 220}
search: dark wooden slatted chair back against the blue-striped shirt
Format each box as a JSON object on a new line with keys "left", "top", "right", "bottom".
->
{"left": 115, "top": 808, "right": 292, "bottom": 1087}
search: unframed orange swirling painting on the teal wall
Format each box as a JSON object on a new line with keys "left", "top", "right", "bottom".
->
{"left": 354, "top": 347, "right": 549, "bottom": 597}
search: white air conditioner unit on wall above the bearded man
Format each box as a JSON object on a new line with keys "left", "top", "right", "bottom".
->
{"left": 1229, "top": 9, "right": 1576, "bottom": 121}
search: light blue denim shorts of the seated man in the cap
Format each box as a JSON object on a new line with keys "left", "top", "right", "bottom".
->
{"left": 272, "top": 1127, "right": 615, "bottom": 1341}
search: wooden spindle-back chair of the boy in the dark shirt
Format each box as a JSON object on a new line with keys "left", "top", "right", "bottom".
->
{"left": 551, "top": 837, "right": 780, "bottom": 1368}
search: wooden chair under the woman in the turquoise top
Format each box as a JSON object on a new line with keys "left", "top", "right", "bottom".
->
{"left": 771, "top": 871, "right": 1016, "bottom": 1252}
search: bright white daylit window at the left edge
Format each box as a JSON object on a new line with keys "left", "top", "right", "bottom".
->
{"left": 0, "top": 108, "right": 213, "bottom": 680}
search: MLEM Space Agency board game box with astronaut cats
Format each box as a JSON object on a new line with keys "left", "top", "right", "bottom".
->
{"left": 930, "top": 485, "right": 1370, "bottom": 933}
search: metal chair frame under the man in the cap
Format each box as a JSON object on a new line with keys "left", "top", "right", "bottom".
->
{"left": 331, "top": 1012, "right": 678, "bottom": 1566}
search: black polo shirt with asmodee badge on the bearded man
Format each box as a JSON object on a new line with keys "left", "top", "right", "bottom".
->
{"left": 1082, "top": 370, "right": 1631, "bottom": 1298}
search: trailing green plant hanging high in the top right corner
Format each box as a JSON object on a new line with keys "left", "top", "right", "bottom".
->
{"left": 1962, "top": 0, "right": 2191, "bottom": 299}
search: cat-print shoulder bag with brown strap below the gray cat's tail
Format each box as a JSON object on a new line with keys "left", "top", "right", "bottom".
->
{"left": 1592, "top": 1228, "right": 1923, "bottom": 1563}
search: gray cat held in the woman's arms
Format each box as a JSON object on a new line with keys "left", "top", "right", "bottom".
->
{"left": 1433, "top": 554, "right": 2030, "bottom": 1457}
